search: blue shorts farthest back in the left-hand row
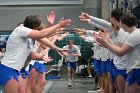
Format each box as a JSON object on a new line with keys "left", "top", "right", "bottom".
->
{"left": 29, "top": 61, "right": 46, "bottom": 74}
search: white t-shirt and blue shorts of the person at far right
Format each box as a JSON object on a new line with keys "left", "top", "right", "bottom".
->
{"left": 126, "top": 29, "right": 140, "bottom": 86}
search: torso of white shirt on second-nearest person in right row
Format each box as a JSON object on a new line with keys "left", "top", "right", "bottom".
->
{"left": 112, "top": 28, "right": 129, "bottom": 69}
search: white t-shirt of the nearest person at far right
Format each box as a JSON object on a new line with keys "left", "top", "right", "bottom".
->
{"left": 126, "top": 29, "right": 140, "bottom": 71}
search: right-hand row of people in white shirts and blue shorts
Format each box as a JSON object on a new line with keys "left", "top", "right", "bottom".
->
{"left": 75, "top": 9, "right": 140, "bottom": 93}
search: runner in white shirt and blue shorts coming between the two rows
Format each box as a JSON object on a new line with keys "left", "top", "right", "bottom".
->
{"left": 63, "top": 40, "right": 81, "bottom": 87}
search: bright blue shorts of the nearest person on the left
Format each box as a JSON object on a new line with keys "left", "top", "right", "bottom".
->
{"left": 0, "top": 64, "right": 19, "bottom": 85}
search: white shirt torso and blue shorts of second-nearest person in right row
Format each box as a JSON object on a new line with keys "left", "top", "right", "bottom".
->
{"left": 112, "top": 28, "right": 129, "bottom": 82}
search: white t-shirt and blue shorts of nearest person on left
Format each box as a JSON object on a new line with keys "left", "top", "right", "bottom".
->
{"left": 0, "top": 24, "right": 32, "bottom": 85}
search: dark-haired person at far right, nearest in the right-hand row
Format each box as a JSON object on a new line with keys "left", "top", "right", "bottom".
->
{"left": 97, "top": 14, "right": 140, "bottom": 93}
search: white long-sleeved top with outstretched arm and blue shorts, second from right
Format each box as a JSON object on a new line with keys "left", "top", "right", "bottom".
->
{"left": 89, "top": 17, "right": 128, "bottom": 82}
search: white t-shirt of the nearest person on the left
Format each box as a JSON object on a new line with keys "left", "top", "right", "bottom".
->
{"left": 1, "top": 25, "right": 32, "bottom": 70}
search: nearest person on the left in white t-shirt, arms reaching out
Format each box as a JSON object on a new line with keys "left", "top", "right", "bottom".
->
{"left": 0, "top": 15, "right": 71, "bottom": 93}
